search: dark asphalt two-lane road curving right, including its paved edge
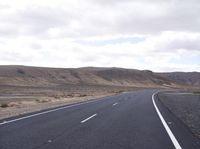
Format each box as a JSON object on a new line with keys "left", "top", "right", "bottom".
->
{"left": 0, "top": 90, "right": 200, "bottom": 149}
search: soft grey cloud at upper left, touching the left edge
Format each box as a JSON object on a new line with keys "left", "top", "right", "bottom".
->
{"left": 0, "top": 6, "right": 69, "bottom": 36}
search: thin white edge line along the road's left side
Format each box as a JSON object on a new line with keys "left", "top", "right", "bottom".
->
{"left": 0, "top": 98, "right": 104, "bottom": 126}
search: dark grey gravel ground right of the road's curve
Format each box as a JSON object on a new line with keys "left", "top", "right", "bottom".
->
{"left": 158, "top": 92, "right": 200, "bottom": 139}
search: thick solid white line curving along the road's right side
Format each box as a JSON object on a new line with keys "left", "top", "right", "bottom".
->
{"left": 152, "top": 92, "right": 182, "bottom": 149}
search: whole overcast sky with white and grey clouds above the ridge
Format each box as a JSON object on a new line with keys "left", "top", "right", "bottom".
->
{"left": 0, "top": 0, "right": 200, "bottom": 72}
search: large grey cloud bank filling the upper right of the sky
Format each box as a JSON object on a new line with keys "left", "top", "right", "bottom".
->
{"left": 65, "top": 0, "right": 200, "bottom": 36}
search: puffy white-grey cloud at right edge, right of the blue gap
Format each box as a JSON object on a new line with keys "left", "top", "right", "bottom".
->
{"left": 146, "top": 32, "right": 200, "bottom": 53}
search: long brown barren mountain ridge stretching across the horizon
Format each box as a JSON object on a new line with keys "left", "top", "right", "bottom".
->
{"left": 0, "top": 66, "right": 200, "bottom": 87}
